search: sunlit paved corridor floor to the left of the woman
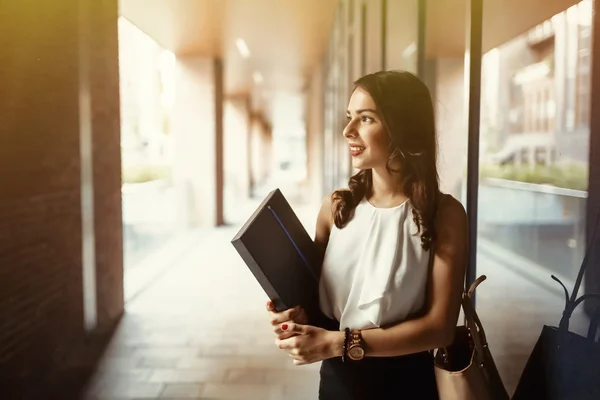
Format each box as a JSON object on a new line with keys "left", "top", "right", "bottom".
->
{"left": 84, "top": 203, "right": 318, "bottom": 400}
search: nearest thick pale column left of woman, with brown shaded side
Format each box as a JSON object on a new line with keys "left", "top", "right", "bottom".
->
{"left": 173, "top": 56, "right": 223, "bottom": 228}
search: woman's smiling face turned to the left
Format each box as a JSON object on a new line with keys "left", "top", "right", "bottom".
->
{"left": 344, "top": 87, "right": 390, "bottom": 169}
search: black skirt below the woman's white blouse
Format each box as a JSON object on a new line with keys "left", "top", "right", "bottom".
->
{"left": 319, "top": 352, "right": 438, "bottom": 400}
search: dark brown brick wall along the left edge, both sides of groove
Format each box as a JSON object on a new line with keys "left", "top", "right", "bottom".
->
{"left": 0, "top": 0, "right": 123, "bottom": 398}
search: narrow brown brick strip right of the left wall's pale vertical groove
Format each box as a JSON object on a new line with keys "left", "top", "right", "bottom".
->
{"left": 91, "top": 0, "right": 123, "bottom": 330}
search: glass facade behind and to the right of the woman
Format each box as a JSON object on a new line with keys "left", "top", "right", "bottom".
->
{"left": 316, "top": 0, "right": 593, "bottom": 391}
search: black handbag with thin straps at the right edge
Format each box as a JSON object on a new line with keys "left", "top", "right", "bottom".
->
{"left": 512, "top": 212, "right": 600, "bottom": 400}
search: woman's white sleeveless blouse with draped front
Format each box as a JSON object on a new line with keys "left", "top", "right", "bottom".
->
{"left": 319, "top": 199, "right": 430, "bottom": 329}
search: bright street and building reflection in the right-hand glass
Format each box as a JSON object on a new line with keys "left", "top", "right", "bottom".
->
{"left": 479, "top": 0, "right": 591, "bottom": 282}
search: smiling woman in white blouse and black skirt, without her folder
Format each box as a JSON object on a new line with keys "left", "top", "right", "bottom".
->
{"left": 267, "top": 71, "right": 467, "bottom": 400}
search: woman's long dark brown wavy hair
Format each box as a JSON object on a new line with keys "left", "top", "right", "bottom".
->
{"left": 332, "top": 71, "right": 439, "bottom": 250}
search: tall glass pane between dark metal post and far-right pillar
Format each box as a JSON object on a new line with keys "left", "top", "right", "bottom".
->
{"left": 477, "top": 0, "right": 592, "bottom": 391}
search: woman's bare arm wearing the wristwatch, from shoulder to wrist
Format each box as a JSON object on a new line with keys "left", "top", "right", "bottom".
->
{"left": 331, "top": 198, "right": 468, "bottom": 357}
